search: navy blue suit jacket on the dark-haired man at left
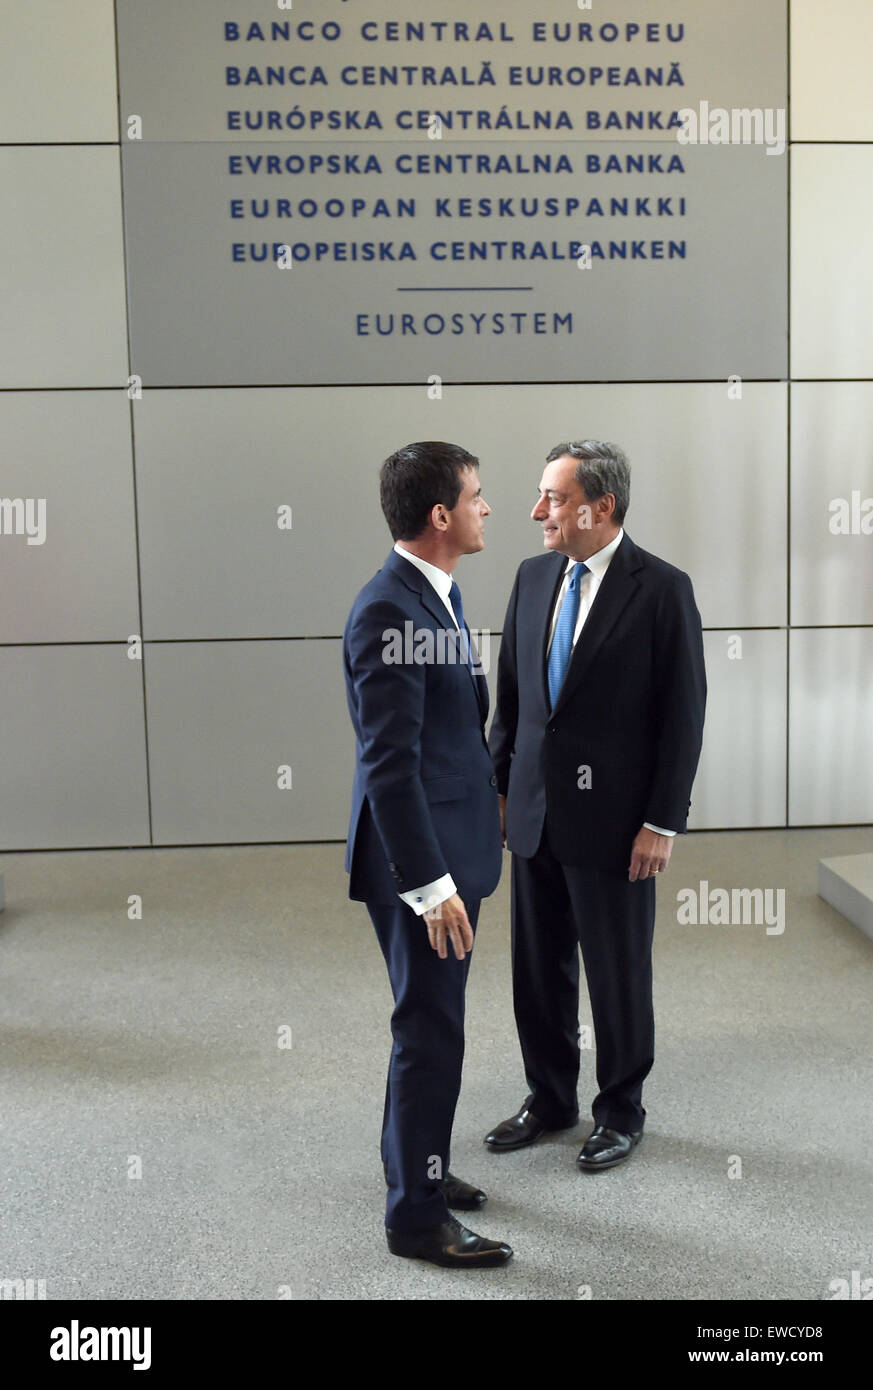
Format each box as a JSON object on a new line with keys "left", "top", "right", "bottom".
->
{"left": 343, "top": 550, "right": 503, "bottom": 905}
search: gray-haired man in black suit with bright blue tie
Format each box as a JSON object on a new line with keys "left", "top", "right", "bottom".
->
{"left": 485, "top": 439, "right": 706, "bottom": 1172}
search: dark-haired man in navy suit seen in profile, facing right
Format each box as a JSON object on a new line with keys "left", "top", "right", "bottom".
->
{"left": 343, "top": 442, "right": 512, "bottom": 1268}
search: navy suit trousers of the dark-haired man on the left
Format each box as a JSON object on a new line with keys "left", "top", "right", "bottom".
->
{"left": 367, "top": 902, "right": 480, "bottom": 1232}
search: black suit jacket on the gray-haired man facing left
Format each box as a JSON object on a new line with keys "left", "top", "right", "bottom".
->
{"left": 489, "top": 532, "right": 706, "bottom": 873}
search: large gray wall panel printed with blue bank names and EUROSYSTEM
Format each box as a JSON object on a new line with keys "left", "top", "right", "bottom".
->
{"left": 112, "top": 0, "right": 788, "bottom": 385}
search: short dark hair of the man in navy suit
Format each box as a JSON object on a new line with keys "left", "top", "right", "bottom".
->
{"left": 380, "top": 439, "right": 480, "bottom": 541}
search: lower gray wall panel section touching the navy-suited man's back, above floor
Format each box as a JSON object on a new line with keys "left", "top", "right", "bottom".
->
{"left": 146, "top": 641, "right": 354, "bottom": 845}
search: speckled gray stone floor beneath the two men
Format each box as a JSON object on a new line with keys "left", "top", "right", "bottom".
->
{"left": 0, "top": 830, "right": 873, "bottom": 1300}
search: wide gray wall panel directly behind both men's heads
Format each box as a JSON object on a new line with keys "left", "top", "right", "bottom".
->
{"left": 135, "top": 384, "right": 787, "bottom": 639}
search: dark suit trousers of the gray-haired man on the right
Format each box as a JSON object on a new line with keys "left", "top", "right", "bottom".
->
{"left": 512, "top": 828, "right": 655, "bottom": 1133}
